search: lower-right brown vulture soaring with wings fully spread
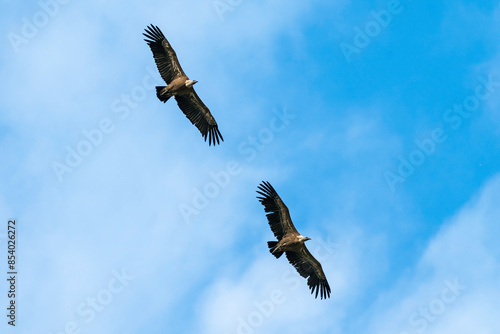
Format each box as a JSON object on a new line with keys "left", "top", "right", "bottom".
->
{"left": 257, "top": 182, "right": 330, "bottom": 299}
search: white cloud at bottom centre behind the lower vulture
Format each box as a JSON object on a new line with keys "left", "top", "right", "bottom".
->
{"left": 195, "top": 223, "right": 390, "bottom": 333}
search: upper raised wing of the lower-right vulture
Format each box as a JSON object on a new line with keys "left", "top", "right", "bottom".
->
{"left": 257, "top": 181, "right": 299, "bottom": 240}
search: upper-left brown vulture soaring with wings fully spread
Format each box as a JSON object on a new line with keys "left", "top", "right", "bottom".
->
{"left": 143, "top": 24, "right": 224, "bottom": 146}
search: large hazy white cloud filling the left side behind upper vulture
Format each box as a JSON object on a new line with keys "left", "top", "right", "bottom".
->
{"left": 1, "top": 1, "right": 332, "bottom": 333}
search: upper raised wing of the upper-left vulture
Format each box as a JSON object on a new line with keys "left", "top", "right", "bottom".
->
{"left": 143, "top": 24, "right": 185, "bottom": 85}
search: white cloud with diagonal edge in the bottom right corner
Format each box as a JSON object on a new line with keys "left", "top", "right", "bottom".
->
{"left": 363, "top": 176, "right": 500, "bottom": 334}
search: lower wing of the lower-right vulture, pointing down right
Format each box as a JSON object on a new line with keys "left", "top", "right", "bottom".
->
{"left": 285, "top": 245, "right": 330, "bottom": 299}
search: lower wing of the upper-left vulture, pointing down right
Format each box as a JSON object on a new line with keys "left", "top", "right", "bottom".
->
{"left": 175, "top": 89, "right": 224, "bottom": 145}
